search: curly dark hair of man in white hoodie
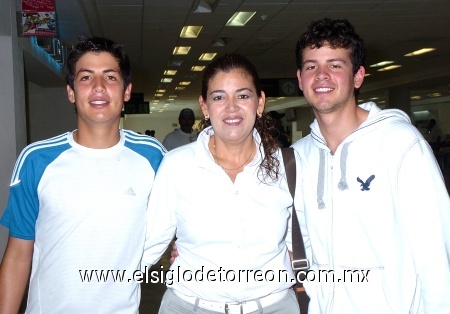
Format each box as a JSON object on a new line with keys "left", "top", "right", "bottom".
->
{"left": 295, "top": 18, "right": 365, "bottom": 95}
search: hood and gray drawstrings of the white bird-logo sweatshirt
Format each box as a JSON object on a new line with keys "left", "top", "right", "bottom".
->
{"left": 310, "top": 102, "right": 410, "bottom": 209}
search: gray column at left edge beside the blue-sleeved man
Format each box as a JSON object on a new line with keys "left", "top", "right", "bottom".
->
{"left": 0, "top": 0, "right": 27, "bottom": 256}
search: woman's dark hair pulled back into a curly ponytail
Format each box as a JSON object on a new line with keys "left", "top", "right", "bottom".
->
{"left": 199, "top": 53, "right": 280, "bottom": 182}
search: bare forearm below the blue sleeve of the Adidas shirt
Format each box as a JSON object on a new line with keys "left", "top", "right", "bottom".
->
{"left": 0, "top": 236, "right": 34, "bottom": 314}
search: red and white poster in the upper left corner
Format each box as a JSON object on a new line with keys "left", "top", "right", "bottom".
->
{"left": 22, "top": 0, "right": 56, "bottom": 37}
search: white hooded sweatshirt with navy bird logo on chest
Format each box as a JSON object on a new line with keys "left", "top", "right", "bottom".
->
{"left": 293, "top": 102, "right": 450, "bottom": 314}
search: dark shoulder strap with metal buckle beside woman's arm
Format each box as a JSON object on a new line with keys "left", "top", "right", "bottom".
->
{"left": 281, "top": 148, "right": 309, "bottom": 290}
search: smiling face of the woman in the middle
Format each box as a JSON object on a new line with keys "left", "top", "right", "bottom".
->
{"left": 199, "top": 69, "right": 265, "bottom": 143}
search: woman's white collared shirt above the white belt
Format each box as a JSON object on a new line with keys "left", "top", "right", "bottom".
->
{"left": 142, "top": 128, "right": 295, "bottom": 302}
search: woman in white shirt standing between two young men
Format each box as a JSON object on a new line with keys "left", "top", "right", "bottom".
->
{"left": 142, "top": 54, "right": 299, "bottom": 314}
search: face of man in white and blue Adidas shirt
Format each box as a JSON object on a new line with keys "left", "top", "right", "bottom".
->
{"left": 67, "top": 52, "right": 131, "bottom": 128}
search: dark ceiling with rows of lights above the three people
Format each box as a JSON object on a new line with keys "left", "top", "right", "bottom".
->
{"left": 25, "top": 0, "right": 450, "bottom": 116}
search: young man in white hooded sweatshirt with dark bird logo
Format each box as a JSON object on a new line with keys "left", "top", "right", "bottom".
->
{"left": 293, "top": 19, "right": 450, "bottom": 314}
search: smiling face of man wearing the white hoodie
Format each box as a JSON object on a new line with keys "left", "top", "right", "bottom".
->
{"left": 297, "top": 45, "right": 365, "bottom": 114}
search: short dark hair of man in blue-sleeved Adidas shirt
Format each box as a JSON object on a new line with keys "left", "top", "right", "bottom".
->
{"left": 64, "top": 37, "right": 131, "bottom": 89}
